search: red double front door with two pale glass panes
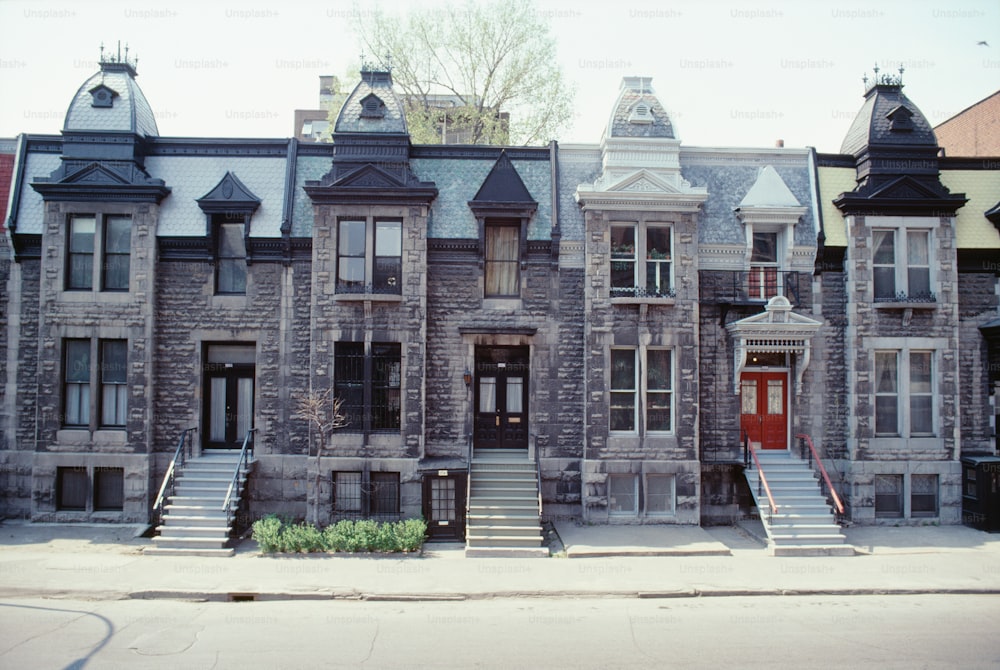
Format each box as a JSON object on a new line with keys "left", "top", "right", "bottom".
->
{"left": 740, "top": 372, "right": 788, "bottom": 449}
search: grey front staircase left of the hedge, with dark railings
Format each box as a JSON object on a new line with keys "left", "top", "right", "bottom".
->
{"left": 143, "top": 449, "right": 247, "bottom": 556}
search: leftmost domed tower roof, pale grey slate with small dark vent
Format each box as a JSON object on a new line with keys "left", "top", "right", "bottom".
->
{"left": 63, "top": 61, "right": 160, "bottom": 137}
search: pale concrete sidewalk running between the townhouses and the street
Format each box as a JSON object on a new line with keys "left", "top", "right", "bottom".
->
{"left": 0, "top": 521, "right": 1000, "bottom": 601}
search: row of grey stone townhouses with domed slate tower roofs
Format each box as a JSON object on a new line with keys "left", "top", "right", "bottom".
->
{"left": 0, "top": 55, "right": 1000, "bottom": 539}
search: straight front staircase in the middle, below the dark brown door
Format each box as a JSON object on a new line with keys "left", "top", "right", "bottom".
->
{"left": 465, "top": 449, "right": 549, "bottom": 558}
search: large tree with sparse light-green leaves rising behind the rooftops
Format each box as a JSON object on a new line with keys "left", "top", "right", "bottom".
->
{"left": 350, "top": 0, "right": 574, "bottom": 145}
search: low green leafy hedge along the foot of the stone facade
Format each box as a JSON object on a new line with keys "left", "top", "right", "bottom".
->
{"left": 253, "top": 514, "right": 427, "bottom": 554}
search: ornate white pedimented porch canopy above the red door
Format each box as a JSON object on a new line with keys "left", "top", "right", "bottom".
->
{"left": 726, "top": 295, "right": 823, "bottom": 394}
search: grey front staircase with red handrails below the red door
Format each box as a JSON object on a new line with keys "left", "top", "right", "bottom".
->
{"left": 745, "top": 449, "right": 854, "bottom": 556}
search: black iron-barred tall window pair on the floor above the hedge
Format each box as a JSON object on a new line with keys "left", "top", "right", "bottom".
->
{"left": 333, "top": 342, "right": 402, "bottom": 433}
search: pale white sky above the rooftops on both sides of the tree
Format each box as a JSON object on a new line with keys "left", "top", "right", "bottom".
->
{"left": 0, "top": 0, "right": 1000, "bottom": 152}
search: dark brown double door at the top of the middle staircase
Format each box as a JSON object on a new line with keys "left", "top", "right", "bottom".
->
{"left": 474, "top": 347, "right": 529, "bottom": 449}
